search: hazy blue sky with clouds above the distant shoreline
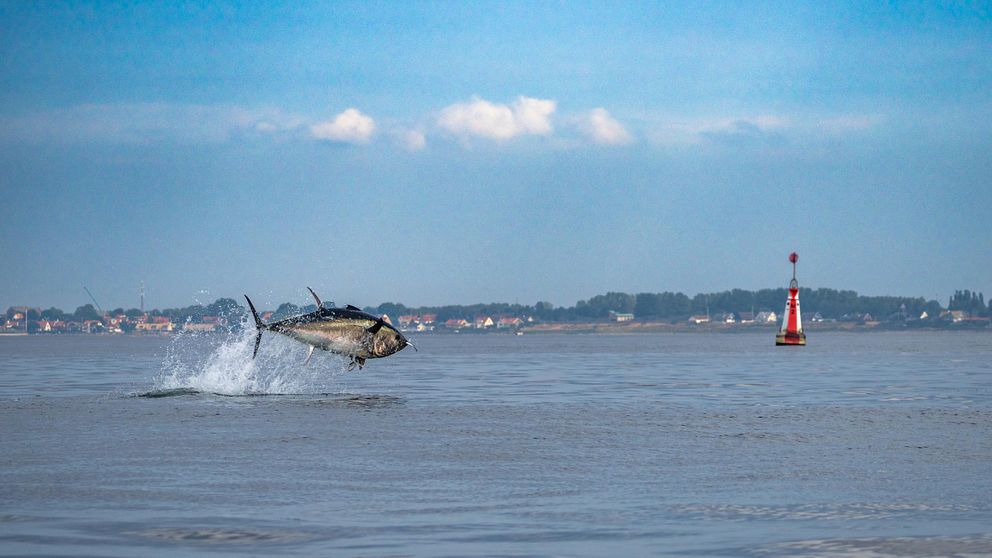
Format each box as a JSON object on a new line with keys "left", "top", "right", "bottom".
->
{"left": 0, "top": 2, "right": 992, "bottom": 310}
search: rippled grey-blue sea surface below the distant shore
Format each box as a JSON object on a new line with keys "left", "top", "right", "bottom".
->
{"left": 0, "top": 332, "right": 992, "bottom": 556}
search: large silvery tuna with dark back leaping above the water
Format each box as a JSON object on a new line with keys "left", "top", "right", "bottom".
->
{"left": 245, "top": 287, "right": 416, "bottom": 370}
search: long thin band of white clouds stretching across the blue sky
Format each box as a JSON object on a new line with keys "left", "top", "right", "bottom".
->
{"left": 0, "top": 96, "right": 889, "bottom": 153}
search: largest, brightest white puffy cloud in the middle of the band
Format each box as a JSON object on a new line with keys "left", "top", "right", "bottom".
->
{"left": 437, "top": 96, "right": 558, "bottom": 140}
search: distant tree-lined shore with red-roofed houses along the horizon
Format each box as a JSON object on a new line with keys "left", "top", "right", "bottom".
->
{"left": 0, "top": 288, "right": 992, "bottom": 335}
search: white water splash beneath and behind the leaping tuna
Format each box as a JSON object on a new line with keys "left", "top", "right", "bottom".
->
{"left": 155, "top": 324, "right": 346, "bottom": 395}
